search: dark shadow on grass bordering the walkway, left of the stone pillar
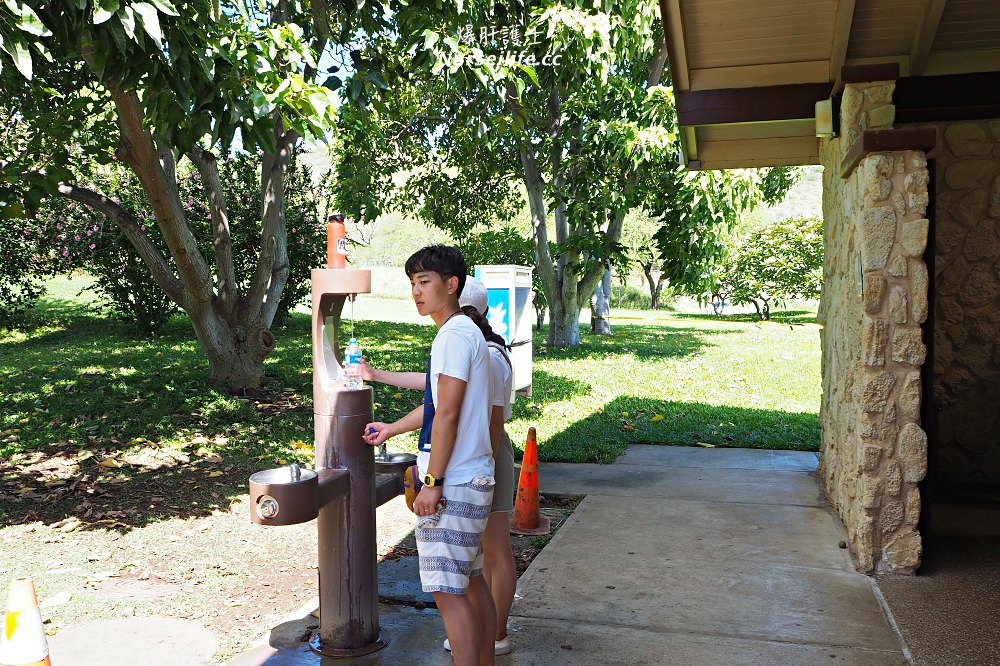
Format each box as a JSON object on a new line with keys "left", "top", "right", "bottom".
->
{"left": 538, "top": 396, "right": 820, "bottom": 463}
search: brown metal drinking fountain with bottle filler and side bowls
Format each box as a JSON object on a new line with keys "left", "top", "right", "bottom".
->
{"left": 250, "top": 268, "right": 416, "bottom": 657}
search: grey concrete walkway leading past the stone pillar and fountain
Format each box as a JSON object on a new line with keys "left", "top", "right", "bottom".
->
{"left": 230, "top": 446, "right": 907, "bottom": 666}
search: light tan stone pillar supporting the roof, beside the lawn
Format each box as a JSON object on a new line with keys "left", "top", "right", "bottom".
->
{"left": 819, "top": 82, "right": 929, "bottom": 572}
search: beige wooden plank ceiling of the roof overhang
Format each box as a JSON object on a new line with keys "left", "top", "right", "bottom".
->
{"left": 660, "top": 0, "right": 1000, "bottom": 169}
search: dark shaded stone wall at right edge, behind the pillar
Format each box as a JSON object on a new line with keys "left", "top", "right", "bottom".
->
{"left": 931, "top": 120, "right": 1000, "bottom": 486}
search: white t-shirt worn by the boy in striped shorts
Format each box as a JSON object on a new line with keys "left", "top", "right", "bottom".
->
{"left": 417, "top": 315, "right": 493, "bottom": 485}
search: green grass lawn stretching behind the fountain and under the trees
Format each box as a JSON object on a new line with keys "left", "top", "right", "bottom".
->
{"left": 0, "top": 272, "right": 820, "bottom": 466}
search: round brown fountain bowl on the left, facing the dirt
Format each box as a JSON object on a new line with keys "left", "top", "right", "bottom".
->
{"left": 250, "top": 463, "right": 319, "bottom": 525}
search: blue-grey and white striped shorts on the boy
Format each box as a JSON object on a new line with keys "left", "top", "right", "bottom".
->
{"left": 415, "top": 476, "right": 494, "bottom": 594}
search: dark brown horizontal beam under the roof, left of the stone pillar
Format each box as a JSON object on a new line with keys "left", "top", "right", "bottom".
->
{"left": 674, "top": 82, "right": 830, "bottom": 125}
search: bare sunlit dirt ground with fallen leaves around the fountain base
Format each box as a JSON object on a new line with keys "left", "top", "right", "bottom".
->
{"left": 0, "top": 442, "right": 579, "bottom": 663}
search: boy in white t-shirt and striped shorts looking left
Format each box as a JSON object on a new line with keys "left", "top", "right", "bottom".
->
{"left": 365, "top": 245, "right": 496, "bottom": 666}
